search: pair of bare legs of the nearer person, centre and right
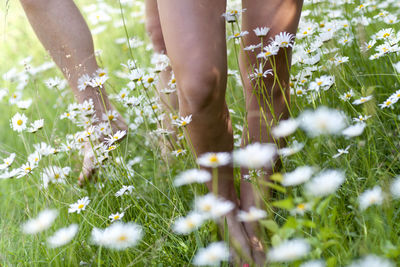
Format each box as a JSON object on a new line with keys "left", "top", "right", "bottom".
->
{"left": 158, "top": 0, "right": 302, "bottom": 265}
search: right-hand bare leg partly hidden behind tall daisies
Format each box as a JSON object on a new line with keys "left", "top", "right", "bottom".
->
{"left": 240, "top": 0, "right": 303, "bottom": 264}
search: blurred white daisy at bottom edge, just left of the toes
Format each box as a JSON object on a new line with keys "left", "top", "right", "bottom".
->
{"left": 193, "top": 242, "right": 229, "bottom": 266}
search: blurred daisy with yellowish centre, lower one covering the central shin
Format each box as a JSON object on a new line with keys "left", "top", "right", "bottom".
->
{"left": 195, "top": 193, "right": 235, "bottom": 219}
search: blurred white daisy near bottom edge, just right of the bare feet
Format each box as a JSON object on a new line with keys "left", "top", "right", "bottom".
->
{"left": 267, "top": 239, "right": 310, "bottom": 262}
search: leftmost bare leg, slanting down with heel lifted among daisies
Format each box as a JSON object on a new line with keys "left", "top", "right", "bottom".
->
{"left": 20, "top": 0, "right": 127, "bottom": 183}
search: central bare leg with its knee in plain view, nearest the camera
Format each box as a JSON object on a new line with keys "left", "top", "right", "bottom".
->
{"left": 158, "top": 0, "right": 250, "bottom": 262}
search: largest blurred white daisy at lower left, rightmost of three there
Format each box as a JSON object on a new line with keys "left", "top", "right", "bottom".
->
{"left": 92, "top": 222, "right": 143, "bottom": 250}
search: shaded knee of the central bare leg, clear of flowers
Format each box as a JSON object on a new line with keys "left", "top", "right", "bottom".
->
{"left": 178, "top": 67, "right": 226, "bottom": 116}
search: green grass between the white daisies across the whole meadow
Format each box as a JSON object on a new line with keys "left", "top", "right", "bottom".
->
{"left": 0, "top": 0, "right": 400, "bottom": 266}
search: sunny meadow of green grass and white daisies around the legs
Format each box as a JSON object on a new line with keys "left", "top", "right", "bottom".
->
{"left": 0, "top": 0, "right": 400, "bottom": 267}
